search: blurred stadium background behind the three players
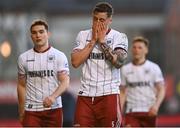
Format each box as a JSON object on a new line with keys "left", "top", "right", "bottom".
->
{"left": 0, "top": 0, "right": 180, "bottom": 126}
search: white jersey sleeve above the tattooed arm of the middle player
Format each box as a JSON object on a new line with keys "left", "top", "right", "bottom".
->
{"left": 114, "top": 33, "right": 128, "bottom": 51}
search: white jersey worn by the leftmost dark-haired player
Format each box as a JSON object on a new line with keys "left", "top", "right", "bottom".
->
{"left": 18, "top": 47, "right": 69, "bottom": 111}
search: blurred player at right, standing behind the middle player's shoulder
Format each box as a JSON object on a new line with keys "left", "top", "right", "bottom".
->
{"left": 120, "top": 36, "right": 165, "bottom": 127}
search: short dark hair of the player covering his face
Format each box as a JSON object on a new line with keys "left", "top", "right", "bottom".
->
{"left": 93, "top": 2, "right": 113, "bottom": 17}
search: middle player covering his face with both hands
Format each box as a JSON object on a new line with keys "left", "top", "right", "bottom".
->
{"left": 71, "top": 2, "right": 128, "bottom": 127}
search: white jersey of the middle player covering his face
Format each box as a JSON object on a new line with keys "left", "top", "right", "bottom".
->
{"left": 73, "top": 29, "right": 128, "bottom": 97}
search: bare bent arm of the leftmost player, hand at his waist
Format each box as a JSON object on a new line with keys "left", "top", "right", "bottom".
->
{"left": 43, "top": 70, "right": 70, "bottom": 107}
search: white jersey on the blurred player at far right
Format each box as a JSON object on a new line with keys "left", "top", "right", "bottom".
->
{"left": 121, "top": 60, "right": 164, "bottom": 112}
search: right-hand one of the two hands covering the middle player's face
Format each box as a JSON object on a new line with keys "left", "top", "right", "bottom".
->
{"left": 97, "top": 22, "right": 107, "bottom": 43}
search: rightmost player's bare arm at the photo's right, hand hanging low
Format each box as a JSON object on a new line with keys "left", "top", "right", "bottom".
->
{"left": 149, "top": 82, "right": 166, "bottom": 116}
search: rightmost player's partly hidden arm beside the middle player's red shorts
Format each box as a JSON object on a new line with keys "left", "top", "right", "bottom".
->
{"left": 120, "top": 86, "right": 127, "bottom": 111}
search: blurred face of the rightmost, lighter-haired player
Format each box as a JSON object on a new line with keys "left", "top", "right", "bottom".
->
{"left": 132, "top": 41, "right": 148, "bottom": 60}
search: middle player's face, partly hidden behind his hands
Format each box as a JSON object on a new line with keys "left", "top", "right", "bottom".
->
{"left": 93, "top": 12, "right": 112, "bottom": 28}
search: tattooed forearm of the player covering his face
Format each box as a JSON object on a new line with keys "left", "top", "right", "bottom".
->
{"left": 100, "top": 42, "right": 127, "bottom": 68}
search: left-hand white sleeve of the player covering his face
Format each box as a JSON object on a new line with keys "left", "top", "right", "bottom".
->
{"left": 73, "top": 31, "right": 85, "bottom": 50}
